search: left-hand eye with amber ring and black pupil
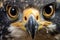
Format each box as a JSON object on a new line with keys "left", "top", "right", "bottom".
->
{"left": 7, "top": 6, "right": 18, "bottom": 20}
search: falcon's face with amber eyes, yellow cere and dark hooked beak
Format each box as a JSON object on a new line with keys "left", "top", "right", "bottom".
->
{"left": 0, "top": 0, "right": 58, "bottom": 38}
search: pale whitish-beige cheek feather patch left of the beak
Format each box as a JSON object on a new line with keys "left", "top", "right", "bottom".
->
{"left": 8, "top": 26, "right": 26, "bottom": 38}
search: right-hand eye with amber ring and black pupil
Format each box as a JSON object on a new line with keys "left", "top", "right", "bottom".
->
{"left": 43, "top": 5, "right": 54, "bottom": 18}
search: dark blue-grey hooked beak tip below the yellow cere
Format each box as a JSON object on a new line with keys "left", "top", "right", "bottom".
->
{"left": 25, "top": 16, "right": 38, "bottom": 39}
